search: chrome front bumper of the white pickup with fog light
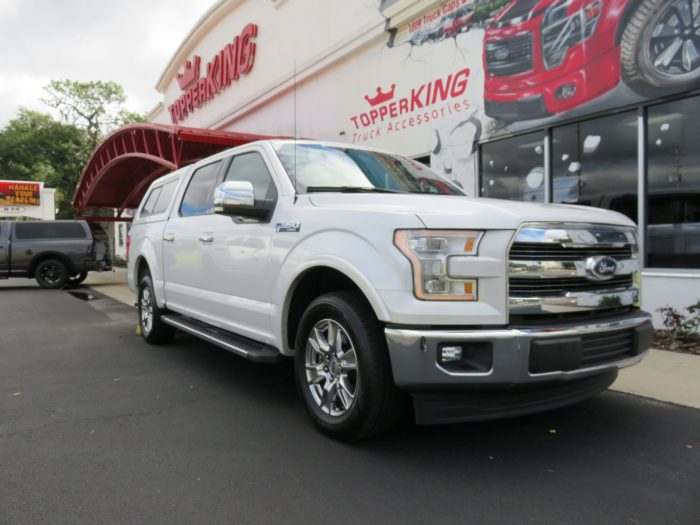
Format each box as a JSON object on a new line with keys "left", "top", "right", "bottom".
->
{"left": 385, "top": 311, "right": 653, "bottom": 391}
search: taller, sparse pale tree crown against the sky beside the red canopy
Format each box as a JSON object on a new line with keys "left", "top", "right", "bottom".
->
{"left": 42, "top": 80, "right": 146, "bottom": 149}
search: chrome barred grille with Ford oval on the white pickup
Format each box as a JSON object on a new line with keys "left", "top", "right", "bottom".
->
{"left": 508, "top": 224, "right": 639, "bottom": 316}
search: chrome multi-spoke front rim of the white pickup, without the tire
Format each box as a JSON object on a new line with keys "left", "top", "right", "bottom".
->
{"left": 305, "top": 319, "right": 358, "bottom": 417}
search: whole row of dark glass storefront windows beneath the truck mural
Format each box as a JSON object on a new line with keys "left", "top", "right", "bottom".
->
{"left": 480, "top": 92, "right": 700, "bottom": 269}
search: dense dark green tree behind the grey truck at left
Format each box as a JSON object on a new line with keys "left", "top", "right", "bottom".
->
{"left": 0, "top": 108, "right": 92, "bottom": 218}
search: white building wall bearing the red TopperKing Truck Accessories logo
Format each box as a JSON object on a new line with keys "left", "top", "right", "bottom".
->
{"left": 154, "top": 0, "right": 488, "bottom": 195}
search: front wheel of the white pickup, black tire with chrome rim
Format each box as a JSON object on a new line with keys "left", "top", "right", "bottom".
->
{"left": 294, "top": 292, "right": 403, "bottom": 441}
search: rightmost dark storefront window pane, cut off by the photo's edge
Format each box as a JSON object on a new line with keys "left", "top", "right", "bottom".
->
{"left": 647, "top": 97, "right": 700, "bottom": 268}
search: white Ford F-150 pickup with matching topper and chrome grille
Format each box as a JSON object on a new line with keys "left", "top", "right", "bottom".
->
{"left": 128, "top": 140, "right": 652, "bottom": 440}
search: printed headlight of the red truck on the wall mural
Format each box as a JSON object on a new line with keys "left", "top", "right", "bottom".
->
{"left": 542, "top": 0, "right": 603, "bottom": 69}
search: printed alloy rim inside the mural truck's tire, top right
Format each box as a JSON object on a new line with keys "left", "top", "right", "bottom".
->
{"left": 647, "top": 0, "right": 700, "bottom": 77}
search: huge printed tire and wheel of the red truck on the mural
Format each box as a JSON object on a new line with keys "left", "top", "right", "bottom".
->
{"left": 620, "top": 0, "right": 700, "bottom": 97}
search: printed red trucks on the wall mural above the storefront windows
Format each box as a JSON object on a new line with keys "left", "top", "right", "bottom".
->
{"left": 384, "top": 0, "right": 700, "bottom": 125}
